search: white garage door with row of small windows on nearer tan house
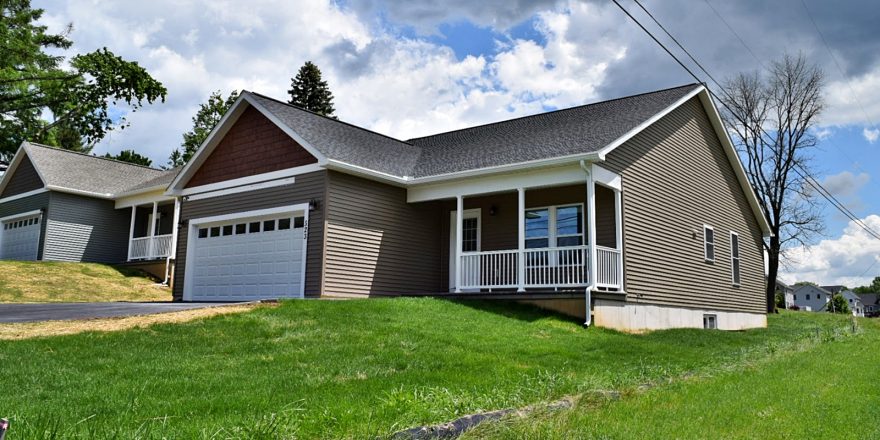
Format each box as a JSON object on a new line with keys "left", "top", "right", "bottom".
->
{"left": 186, "top": 214, "right": 306, "bottom": 301}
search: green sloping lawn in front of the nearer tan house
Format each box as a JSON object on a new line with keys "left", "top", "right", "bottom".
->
{"left": 0, "top": 299, "right": 864, "bottom": 439}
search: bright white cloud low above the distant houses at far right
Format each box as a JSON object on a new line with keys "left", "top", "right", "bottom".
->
{"left": 782, "top": 214, "right": 880, "bottom": 287}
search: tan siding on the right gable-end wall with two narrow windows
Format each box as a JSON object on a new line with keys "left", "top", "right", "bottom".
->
{"left": 602, "top": 98, "right": 764, "bottom": 313}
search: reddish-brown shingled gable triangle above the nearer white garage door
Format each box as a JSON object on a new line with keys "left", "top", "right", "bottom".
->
{"left": 186, "top": 107, "right": 318, "bottom": 188}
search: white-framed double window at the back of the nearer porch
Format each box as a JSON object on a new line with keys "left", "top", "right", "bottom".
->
{"left": 525, "top": 205, "right": 584, "bottom": 249}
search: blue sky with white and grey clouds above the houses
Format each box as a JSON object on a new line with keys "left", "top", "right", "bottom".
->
{"left": 33, "top": 0, "right": 880, "bottom": 286}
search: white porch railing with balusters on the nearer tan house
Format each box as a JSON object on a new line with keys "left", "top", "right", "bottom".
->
{"left": 461, "top": 246, "right": 623, "bottom": 290}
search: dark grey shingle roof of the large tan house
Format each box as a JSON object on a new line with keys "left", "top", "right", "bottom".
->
{"left": 248, "top": 84, "right": 700, "bottom": 177}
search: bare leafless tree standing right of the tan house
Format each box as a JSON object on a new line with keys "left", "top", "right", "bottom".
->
{"left": 721, "top": 55, "right": 824, "bottom": 312}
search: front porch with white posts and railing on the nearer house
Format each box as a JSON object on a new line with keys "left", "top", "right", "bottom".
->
{"left": 428, "top": 165, "right": 624, "bottom": 295}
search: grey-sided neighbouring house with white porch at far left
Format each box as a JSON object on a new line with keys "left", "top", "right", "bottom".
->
{"left": 0, "top": 142, "right": 177, "bottom": 278}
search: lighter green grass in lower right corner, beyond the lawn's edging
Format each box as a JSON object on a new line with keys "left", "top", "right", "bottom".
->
{"left": 465, "top": 314, "right": 880, "bottom": 439}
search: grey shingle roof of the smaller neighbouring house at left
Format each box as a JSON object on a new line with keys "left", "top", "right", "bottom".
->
{"left": 28, "top": 143, "right": 177, "bottom": 196}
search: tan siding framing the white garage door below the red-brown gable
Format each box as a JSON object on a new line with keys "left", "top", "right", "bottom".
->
{"left": 174, "top": 171, "right": 327, "bottom": 300}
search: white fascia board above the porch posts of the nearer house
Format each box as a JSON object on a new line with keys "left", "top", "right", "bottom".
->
{"left": 406, "top": 163, "right": 586, "bottom": 203}
